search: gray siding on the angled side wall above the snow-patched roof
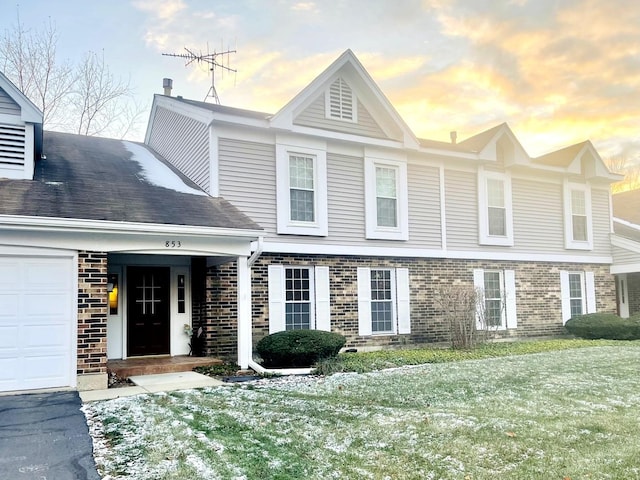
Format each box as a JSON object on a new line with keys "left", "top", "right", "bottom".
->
{"left": 149, "top": 107, "right": 210, "bottom": 192}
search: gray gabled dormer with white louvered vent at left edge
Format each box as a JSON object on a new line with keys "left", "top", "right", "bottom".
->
{"left": 0, "top": 73, "right": 43, "bottom": 180}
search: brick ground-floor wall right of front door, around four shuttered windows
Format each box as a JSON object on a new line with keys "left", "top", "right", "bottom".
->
{"left": 202, "top": 254, "right": 616, "bottom": 355}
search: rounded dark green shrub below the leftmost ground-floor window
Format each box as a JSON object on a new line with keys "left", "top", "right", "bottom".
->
{"left": 256, "top": 330, "right": 346, "bottom": 368}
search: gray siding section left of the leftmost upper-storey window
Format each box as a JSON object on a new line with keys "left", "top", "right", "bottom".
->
{"left": 218, "top": 138, "right": 276, "bottom": 232}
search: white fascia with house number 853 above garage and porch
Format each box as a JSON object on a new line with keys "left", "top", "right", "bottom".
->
{"left": 0, "top": 215, "right": 263, "bottom": 257}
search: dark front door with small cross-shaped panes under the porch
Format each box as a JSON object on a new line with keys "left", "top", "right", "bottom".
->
{"left": 127, "top": 267, "right": 170, "bottom": 356}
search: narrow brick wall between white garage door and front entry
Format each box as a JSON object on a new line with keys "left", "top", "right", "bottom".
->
{"left": 77, "top": 251, "right": 107, "bottom": 375}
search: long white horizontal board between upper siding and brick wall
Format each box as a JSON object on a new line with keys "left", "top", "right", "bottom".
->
{"left": 263, "top": 240, "right": 613, "bottom": 264}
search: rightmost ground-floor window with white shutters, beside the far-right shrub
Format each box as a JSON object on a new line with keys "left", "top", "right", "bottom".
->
{"left": 560, "top": 271, "right": 596, "bottom": 325}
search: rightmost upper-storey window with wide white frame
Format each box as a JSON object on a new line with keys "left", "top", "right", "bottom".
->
{"left": 564, "top": 181, "right": 593, "bottom": 250}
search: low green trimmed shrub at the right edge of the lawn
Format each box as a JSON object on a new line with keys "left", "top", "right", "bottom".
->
{"left": 565, "top": 313, "right": 640, "bottom": 340}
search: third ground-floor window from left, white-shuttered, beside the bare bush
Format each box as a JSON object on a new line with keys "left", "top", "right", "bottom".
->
{"left": 473, "top": 268, "right": 518, "bottom": 330}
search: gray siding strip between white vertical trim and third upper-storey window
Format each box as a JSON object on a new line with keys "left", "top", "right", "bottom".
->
{"left": 444, "top": 170, "right": 478, "bottom": 250}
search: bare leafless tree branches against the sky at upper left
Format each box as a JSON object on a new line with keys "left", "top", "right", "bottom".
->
{"left": 0, "top": 12, "right": 146, "bottom": 138}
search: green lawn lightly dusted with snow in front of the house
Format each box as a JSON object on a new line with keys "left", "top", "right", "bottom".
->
{"left": 85, "top": 342, "right": 640, "bottom": 480}
